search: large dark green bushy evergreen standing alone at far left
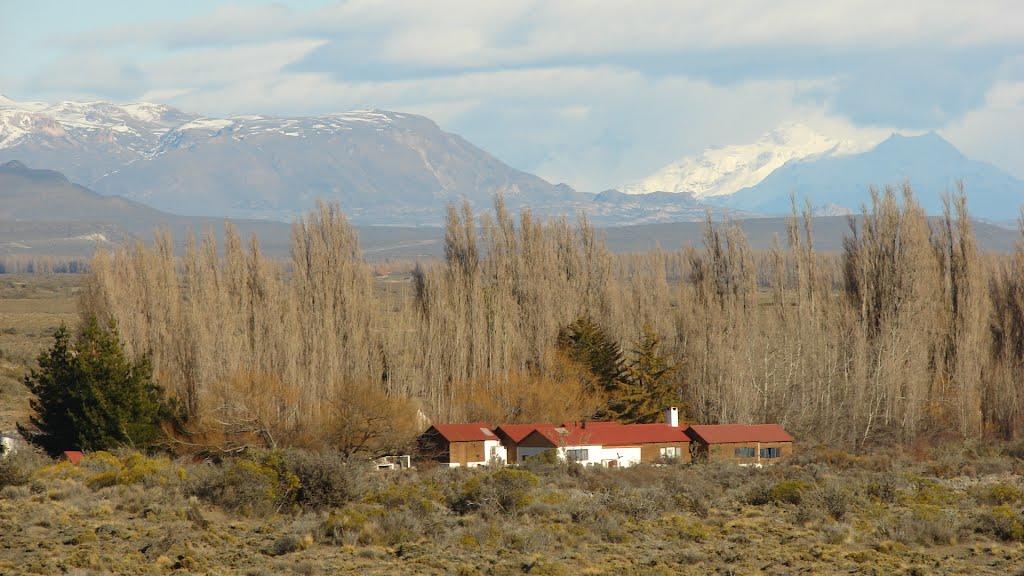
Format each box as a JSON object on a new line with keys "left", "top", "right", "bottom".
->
{"left": 18, "top": 318, "right": 172, "bottom": 453}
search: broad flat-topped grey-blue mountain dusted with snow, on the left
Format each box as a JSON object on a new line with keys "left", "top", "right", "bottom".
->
{"left": 0, "top": 98, "right": 585, "bottom": 223}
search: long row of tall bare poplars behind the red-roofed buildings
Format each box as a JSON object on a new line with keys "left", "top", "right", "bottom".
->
{"left": 83, "top": 187, "right": 1024, "bottom": 447}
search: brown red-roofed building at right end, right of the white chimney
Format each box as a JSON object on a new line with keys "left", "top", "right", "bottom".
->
{"left": 686, "top": 424, "right": 794, "bottom": 465}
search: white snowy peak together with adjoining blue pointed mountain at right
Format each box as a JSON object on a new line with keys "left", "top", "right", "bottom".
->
{"left": 620, "top": 124, "right": 1024, "bottom": 221}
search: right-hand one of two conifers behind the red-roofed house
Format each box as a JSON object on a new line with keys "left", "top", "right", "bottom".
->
{"left": 608, "top": 326, "right": 680, "bottom": 423}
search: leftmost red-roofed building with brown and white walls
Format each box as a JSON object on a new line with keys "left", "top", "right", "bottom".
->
{"left": 418, "top": 422, "right": 508, "bottom": 468}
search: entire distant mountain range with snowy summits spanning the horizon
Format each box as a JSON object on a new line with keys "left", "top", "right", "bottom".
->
{"left": 0, "top": 96, "right": 1024, "bottom": 225}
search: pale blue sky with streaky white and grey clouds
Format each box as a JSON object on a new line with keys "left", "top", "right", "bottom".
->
{"left": 0, "top": 0, "right": 1024, "bottom": 192}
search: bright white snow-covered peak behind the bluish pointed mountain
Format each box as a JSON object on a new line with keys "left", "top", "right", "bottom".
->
{"left": 620, "top": 123, "right": 872, "bottom": 200}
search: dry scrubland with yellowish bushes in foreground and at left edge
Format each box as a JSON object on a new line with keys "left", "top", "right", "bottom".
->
{"left": 6, "top": 276, "right": 1024, "bottom": 575}
